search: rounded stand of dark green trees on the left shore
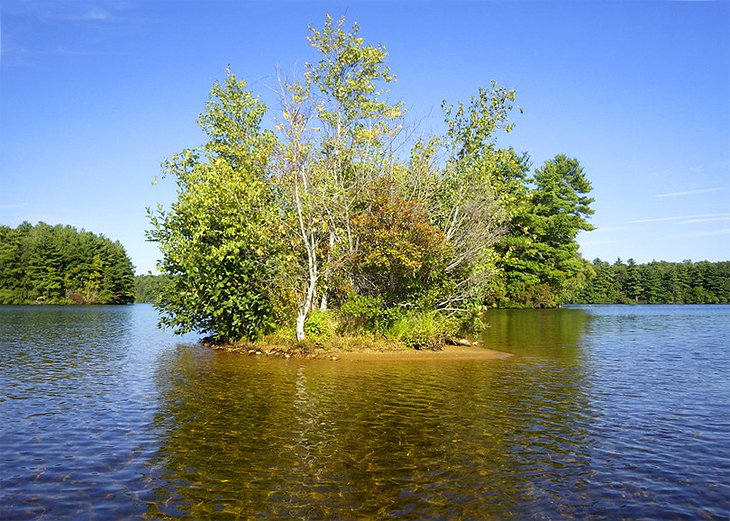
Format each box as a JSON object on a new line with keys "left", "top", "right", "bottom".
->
{"left": 0, "top": 222, "right": 134, "bottom": 304}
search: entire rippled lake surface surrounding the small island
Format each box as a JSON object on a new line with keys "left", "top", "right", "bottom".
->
{"left": 0, "top": 305, "right": 730, "bottom": 521}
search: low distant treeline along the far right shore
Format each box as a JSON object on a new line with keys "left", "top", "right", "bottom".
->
{"left": 574, "top": 259, "right": 730, "bottom": 304}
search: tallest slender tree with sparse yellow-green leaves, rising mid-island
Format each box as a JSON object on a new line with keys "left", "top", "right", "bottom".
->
{"left": 300, "top": 15, "right": 404, "bottom": 300}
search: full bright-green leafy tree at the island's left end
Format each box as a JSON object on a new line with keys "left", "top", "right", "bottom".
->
{"left": 148, "top": 72, "right": 280, "bottom": 341}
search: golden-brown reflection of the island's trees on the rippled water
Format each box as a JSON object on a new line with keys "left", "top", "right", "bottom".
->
{"left": 148, "top": 322, "right": 591, "bottom": 519}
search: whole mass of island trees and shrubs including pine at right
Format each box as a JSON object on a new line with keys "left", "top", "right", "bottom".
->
{"left": 148, "top": 17, "right": 593, "bottom": 346}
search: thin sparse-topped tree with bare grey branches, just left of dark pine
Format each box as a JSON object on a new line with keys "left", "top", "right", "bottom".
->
{"left": 432, "top": 88, "right": 521, "bottom": 310}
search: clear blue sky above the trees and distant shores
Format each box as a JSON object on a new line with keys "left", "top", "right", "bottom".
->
{"left": 0, "top": 0, "right": 730, "bottom": 272}
